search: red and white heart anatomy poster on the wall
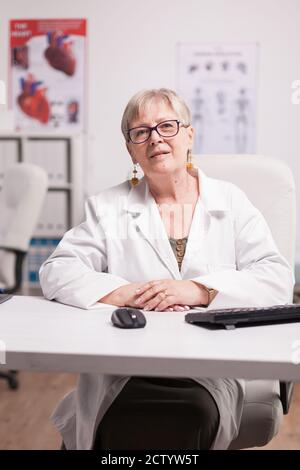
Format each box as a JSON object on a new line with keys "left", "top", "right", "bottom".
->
{"left": 9, "top": 19, "right": 86, "bottom": 132}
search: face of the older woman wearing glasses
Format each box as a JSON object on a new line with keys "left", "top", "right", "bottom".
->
{"left": 126, "top": 99, "right": 194, "bottom": 177}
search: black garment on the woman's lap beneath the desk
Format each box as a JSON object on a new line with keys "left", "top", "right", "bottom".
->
{"left": 93, "top": 377, "right": 219, "bottom": 450}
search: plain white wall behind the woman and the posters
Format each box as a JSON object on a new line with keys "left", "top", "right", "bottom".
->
{"left": 0, "top": 0, "right": 300, "bottom": 263}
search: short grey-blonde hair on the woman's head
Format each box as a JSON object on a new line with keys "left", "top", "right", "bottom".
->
{"left": 121, "top": 88, "right": 191, "bottom": 140}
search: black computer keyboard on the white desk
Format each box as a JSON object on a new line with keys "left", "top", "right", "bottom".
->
{"left": 185, "top": 304, "right": 300, "bottom": 329}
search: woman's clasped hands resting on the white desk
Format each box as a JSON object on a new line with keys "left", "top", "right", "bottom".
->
{"left": 134, "top": 279, "right": 208, "bottom": 311}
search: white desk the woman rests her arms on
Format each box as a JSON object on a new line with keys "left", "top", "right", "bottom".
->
{"left": 0, "top": 296, "right": 300, "bottom": 380}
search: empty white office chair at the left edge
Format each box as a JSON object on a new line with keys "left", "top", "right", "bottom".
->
{"left": 0, "top": 163, "right": 47, "bottom": 389}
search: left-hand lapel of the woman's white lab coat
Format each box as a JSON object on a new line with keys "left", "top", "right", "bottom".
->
{"left": 127, "top": 178, "right": 181, "bottom": 279}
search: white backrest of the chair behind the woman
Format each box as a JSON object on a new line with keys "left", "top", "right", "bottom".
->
{"left": 194, "top": 155, "right": 296, "bottom": 267}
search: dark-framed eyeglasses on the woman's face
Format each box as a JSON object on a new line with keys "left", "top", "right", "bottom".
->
{"left": 127, "top": 119, "right": 190, "bottom": 144}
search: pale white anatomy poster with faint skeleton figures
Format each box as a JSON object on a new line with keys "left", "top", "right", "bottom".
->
{"left": 177, "top": 43, "right": 258, "bottom": 154}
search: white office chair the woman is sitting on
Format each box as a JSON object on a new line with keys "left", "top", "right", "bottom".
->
{"left": 96, "top": 155, "right": 296, "bottom": 449}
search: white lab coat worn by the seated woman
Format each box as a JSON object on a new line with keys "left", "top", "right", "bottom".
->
{"left": 40, "top": 171, "right": 294, "bottom": 449}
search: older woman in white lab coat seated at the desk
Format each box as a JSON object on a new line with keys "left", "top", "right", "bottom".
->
{"left": 41, "top": 89, "right": 293, "bottom": 449}
